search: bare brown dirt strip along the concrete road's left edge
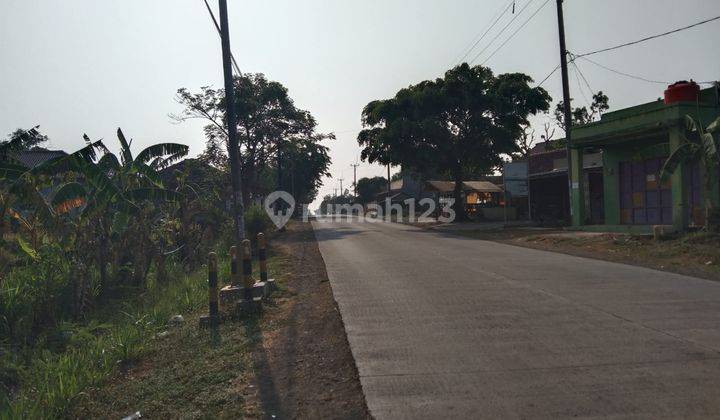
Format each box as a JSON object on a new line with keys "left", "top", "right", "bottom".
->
{"left": 250, "top": 222, "right": 370, "bottom": 419}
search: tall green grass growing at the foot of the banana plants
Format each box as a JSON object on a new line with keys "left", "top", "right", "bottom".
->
{"left": 0, "top": 260, "right": 207, "bottom": 418}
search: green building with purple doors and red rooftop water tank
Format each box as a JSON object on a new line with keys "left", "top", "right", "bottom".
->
{"left": 571, "top": 85, "right": 720, "bottom": 231}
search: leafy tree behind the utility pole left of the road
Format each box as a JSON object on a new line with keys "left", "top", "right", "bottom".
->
{"left": 173, "top": 73, "right": 334, "bottom": 202}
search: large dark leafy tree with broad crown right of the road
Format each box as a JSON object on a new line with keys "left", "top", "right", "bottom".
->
{"left": 358, "top": 64, "right": 551, "bottom": 220}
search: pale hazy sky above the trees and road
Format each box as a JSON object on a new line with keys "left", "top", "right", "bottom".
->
{"left": 0, "top": 0, "right": 720, "bottom": 208}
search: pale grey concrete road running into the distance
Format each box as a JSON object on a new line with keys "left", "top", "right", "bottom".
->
{"left": 314, "top": 221, "right": 720, "bottom": 419}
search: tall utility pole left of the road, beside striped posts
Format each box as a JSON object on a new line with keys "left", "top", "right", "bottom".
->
{"left": 218, "top": 0, "right": 245, "bottom": 241}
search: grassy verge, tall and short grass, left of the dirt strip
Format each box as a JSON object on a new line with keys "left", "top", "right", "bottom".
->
{"left": 0, "top": 248, "right": 284, "bottom": 418}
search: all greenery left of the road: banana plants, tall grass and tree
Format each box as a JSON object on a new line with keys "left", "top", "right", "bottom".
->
{"left": 0, "top": 71, "right": 332, "bottom": 418}
